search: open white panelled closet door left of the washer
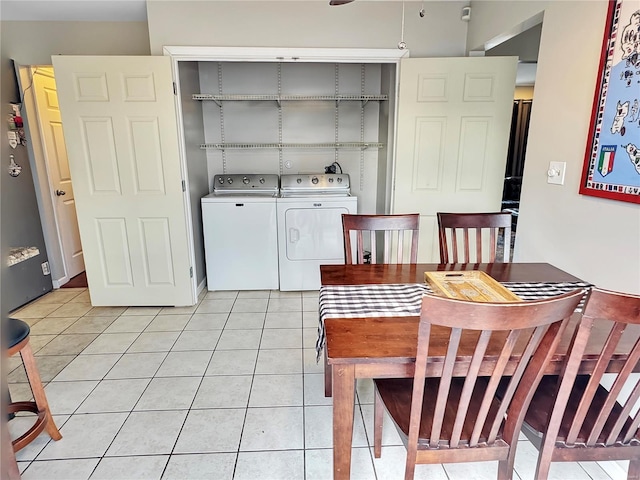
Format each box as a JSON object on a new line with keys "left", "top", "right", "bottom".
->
{"left": 53, "top": 56, "right": 196, "bottom": 305}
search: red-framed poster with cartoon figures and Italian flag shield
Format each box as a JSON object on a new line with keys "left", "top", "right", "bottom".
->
{"left": 580, "top": 0, "right": 640, "bottom": 203}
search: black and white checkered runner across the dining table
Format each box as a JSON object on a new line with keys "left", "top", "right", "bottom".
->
{"left": 316, "top": 282, "right": 591, "bottom": 358}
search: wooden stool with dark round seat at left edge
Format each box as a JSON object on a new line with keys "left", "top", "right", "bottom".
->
{"left": 3, "top": 318, "right": 62, "bottom": 452}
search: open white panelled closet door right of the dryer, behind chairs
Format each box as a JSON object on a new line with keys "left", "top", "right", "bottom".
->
{"left": 391, "top": 57, "right": 517, "bottom": 262}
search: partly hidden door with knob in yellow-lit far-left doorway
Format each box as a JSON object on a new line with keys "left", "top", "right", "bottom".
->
{"left": 33, "top": 67, "right": 84, "bottom": 283}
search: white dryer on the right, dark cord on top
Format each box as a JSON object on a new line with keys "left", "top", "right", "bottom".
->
{"left": 276, "top": 174, "right": 358, "bottom": 291}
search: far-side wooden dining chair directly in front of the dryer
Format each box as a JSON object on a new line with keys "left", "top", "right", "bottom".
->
{"left": 342, "top": 213, "right": 420, "bottom": 264}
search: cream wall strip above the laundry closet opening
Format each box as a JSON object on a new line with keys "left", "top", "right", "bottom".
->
{"left": 147, "top": 0, "right": 468, "bottom": 57}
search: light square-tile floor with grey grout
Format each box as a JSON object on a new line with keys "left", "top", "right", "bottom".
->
{"left": 6, "top": 289, "right": 626, "bottom": 480}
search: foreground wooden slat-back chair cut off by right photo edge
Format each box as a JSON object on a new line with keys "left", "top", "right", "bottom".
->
{"left": 522, "top": 288, "right": 640, "bottom": 479}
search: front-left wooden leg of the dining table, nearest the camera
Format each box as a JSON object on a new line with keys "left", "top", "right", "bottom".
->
{"left": 332, "top": 365, "right": 356, "bottom": 480}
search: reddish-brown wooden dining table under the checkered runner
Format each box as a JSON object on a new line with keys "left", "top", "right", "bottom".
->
{"left": 318, "top": 263, "right": 595, "bottom": 479}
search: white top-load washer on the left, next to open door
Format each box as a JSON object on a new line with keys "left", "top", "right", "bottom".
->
{"left": 201, "top": 174, "right": 279, "bottom": 290}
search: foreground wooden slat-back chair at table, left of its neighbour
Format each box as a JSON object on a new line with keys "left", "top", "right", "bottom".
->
{"left": 374, "top": 290, "right": 585, "bottom": 479}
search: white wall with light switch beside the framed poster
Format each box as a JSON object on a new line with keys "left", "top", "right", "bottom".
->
{"left": 469, "top": 0, "right": 640, "bottom": 293}
